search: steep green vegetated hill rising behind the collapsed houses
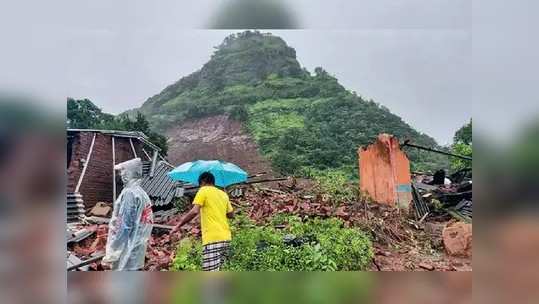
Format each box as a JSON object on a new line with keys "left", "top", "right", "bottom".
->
{"left": 133, "top": 31, "right": 447, "bottom": 176}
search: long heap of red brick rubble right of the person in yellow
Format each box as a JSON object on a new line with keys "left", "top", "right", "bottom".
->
{"left": 233, "top": 184, "right": 471, "bottom": 271}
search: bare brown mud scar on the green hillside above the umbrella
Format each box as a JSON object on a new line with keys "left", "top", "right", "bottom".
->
{"left": 166, "top": 115, "right": 272, "bottom": 174}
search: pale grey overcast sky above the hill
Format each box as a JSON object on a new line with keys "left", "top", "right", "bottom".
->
{"left": 0, "top": 0, "right": 538, "bottom": 144}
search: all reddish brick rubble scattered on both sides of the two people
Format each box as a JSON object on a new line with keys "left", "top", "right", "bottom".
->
{"left": 68, "top": 170, "right": 471, "bottom": 271}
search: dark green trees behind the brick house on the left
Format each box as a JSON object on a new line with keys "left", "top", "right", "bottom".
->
{"left": 67, "top": 98, "right": 168, "bottom": 155}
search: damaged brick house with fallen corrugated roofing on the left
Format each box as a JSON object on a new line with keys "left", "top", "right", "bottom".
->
{"left": 67, "top": 129, "right": 183, "bottom": 222}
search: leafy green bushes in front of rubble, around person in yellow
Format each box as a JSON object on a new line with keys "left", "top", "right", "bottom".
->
{"left": 172, "top": 216, "right": 373, "bottom": 271}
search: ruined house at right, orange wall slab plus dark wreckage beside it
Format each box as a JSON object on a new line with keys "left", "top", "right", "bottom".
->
{"left": 358, "top": 134, "right": 473, "bottom": 222}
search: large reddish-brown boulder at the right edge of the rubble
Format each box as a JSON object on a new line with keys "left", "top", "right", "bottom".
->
{"left": 442, "top": 222, "right": 472, "bottom": 257}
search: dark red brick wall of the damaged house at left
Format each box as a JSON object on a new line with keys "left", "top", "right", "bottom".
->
{"left": 67, "top": 132, "right": 150, "bottom": 208}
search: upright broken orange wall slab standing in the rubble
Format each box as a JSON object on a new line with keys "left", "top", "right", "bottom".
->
{"left": 358, "top": 134, "right": 412, "bottom": 208}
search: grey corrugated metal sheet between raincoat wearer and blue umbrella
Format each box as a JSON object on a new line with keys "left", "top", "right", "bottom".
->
{"left": 141, "top": 161, "right": 181, "bottom": 206}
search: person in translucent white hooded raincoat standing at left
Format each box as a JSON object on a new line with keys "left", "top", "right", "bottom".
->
{"left": 102, "top": 158, "right": 153, "bottom": 270}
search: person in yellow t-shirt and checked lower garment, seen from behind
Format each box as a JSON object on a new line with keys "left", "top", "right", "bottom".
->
{"left": 172, "top": 172, "right": 234, "bottom": 271}
